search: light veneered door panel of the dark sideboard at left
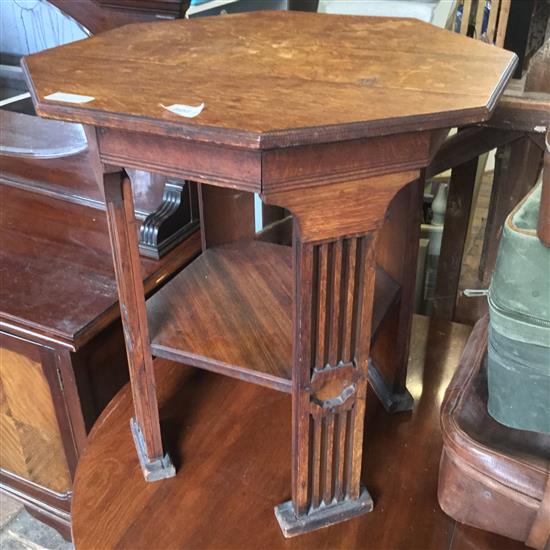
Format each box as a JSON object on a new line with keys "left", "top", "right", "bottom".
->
{"left": 0, "top": 338, "right": 71, "bottom": 493}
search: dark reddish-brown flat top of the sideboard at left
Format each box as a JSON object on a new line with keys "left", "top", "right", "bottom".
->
{"left": 0, "top": 185, "right": 200, "bottom": 347}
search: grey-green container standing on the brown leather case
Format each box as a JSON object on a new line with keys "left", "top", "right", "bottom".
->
{"left": 487, "top": 184, "right": 550, "bottom": 433}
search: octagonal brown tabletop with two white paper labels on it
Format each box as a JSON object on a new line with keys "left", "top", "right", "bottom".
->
{"left": 23, "top": 11, "right": 517, "bottom": 149}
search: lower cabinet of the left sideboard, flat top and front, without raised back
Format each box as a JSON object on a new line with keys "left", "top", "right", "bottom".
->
{"left": 0, "top": 183, "right": 200, "bottom": 537}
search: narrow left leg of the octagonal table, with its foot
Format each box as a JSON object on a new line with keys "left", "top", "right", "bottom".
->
{"left": 103, "top": 174, "right": 175, "bottom": 481}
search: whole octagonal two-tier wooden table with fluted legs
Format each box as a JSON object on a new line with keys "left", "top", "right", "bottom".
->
{"left": 23, "top": 12, "right": 515, "bottom": 536}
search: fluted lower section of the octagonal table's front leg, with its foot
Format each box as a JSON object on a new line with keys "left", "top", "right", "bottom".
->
{"left": 276, "top": 231, "right": 375, "bottom": 537}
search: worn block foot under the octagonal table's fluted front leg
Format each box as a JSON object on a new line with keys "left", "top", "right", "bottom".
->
{"left": 275, "top": 487, "right": 373, "bottom": 538}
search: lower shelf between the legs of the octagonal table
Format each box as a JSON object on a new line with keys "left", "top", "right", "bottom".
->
{"left": 147, "top": 241, "right": 399, "bottom": 393}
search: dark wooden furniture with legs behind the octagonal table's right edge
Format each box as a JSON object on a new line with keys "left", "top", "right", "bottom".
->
{"left": 432, "top": 39, "right": 550, "bottom": 320}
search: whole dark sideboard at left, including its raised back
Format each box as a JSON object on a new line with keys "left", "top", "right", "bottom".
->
{"left": 0, "top": 0, "right": 205, "bottom": 538}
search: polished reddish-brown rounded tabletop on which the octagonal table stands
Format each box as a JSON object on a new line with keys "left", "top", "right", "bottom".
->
{"left": 72, "top": 317, "right": 525, "bottom": 550}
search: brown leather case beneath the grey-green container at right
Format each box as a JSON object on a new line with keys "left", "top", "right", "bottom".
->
{"left": 438, "top": 317, "right": 550, "bottom": 550}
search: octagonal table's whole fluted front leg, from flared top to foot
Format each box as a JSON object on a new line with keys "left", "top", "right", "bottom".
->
{"left": 267, "top": 172, "right": 418, "bottom": 537}
